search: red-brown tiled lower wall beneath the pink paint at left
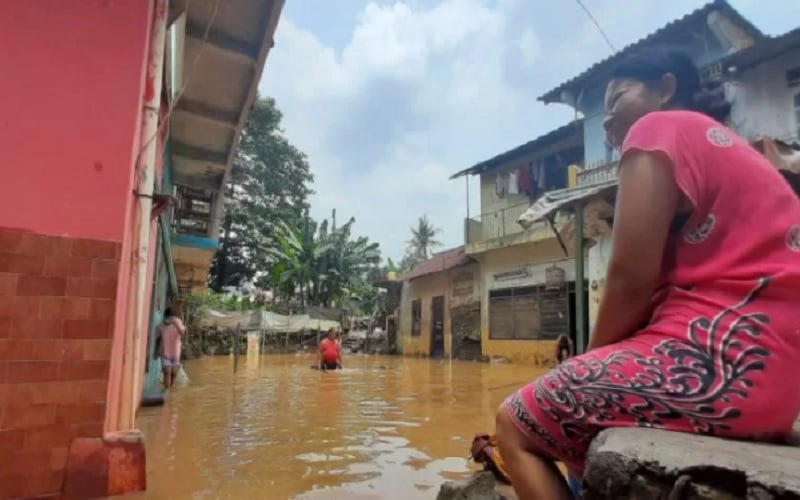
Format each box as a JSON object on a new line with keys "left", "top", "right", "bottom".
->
{"left": 0, "top": 228, "right": 120, "bottom": 498}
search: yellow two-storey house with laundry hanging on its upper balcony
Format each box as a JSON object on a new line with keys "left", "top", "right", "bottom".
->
{"left": 452, "top": 120, "right": 584, "bottom": 364}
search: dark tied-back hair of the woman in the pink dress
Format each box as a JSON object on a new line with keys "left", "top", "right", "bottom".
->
{"left": 612, "top": 50, "right": 731, "bottom": 121}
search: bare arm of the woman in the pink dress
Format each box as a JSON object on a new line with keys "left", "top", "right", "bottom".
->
{"left": 589, "top": 151, "right": 681, "bottom": 350}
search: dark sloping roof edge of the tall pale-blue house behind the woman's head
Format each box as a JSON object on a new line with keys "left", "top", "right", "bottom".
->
{"left": 537, "top": 0, "right": 767, "bottom": 104}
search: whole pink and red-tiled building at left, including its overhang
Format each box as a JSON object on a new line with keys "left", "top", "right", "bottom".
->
{"left": 0, "top": 0, "right": 282, "bottom": 498}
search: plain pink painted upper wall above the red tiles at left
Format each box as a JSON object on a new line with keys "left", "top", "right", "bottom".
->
{"left": 0, "top": 0, "right": 151, "bottom": 241}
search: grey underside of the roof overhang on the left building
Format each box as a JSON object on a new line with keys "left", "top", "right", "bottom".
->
{"left": 170, "top": 0, "right": 284, "bottom": 190}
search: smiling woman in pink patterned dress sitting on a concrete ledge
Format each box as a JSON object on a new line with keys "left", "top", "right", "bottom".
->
{"left": 497, "top": 48, "right": 800, "bottom": 500}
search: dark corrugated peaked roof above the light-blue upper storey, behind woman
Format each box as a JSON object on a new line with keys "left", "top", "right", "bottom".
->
{"left": 539, "top": 0, "right": 765, "bottom": 104}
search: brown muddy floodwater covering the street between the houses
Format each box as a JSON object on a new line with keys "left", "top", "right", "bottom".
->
{"left": 138, "top": 355, "right": 541, "bottom": 499}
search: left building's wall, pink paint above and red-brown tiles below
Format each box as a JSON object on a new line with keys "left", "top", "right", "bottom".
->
{"left": 0, "top": 0, "right": 156, "bottom": 498}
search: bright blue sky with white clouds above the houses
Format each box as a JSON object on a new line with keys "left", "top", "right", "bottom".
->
{"left": 259, "top": 0, "right": 798, "bottom": 259}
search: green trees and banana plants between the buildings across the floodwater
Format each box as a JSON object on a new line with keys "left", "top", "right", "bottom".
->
{"left": 203, "top": 94, "right": 386, "bottom": 311}
